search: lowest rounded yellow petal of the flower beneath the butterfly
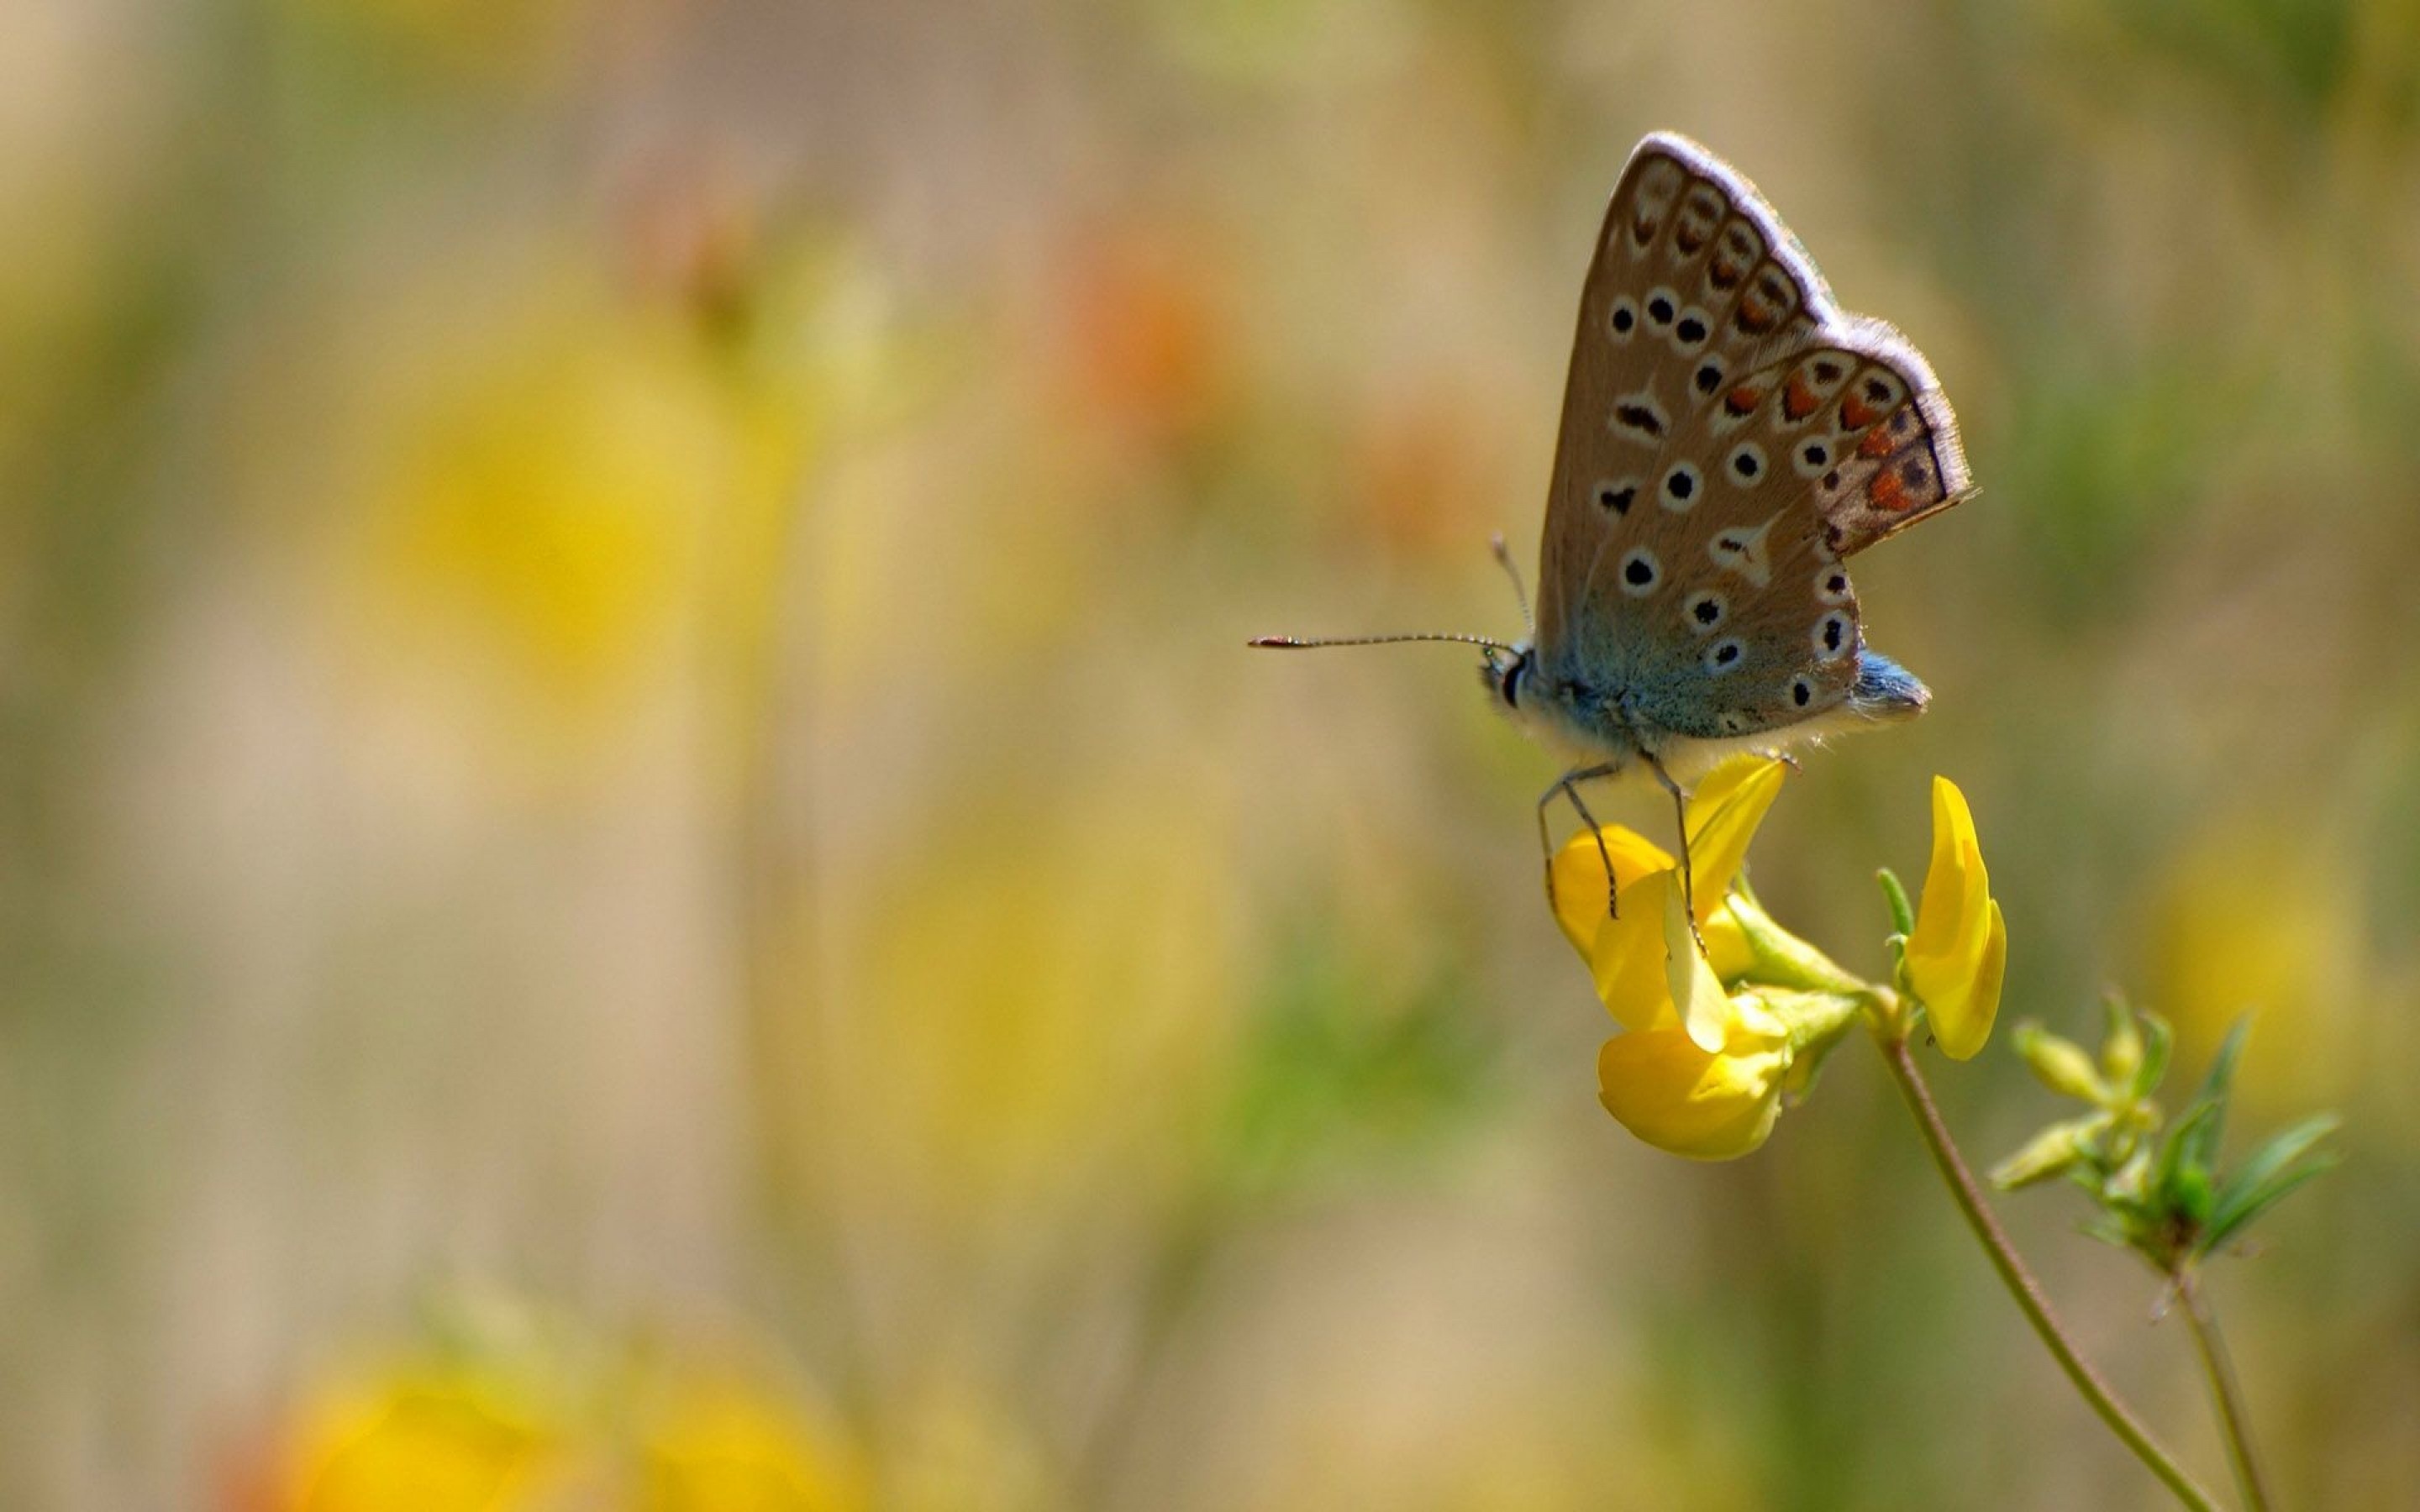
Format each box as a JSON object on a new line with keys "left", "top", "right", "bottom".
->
{"left": 1597, "top": 1026, "right": 1788, "bottom": 1161}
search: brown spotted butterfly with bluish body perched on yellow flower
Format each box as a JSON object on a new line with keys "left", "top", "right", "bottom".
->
{"left": 1254, "top": 131, "right": 1975, "bottom": 915}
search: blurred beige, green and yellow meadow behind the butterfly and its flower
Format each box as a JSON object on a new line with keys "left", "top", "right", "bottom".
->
{"left": 0, "top": 0, "right": 2420, "bottom": 1512}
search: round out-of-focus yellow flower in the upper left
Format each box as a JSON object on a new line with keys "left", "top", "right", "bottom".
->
{"left": 360, "top": 297, "right": 738, "bottom": 711}
